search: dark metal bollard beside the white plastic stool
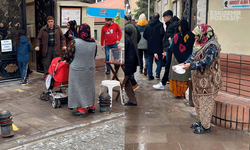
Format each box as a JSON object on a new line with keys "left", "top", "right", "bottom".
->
{"left": 99, "top": 93, "right": 111, "bottom": 112}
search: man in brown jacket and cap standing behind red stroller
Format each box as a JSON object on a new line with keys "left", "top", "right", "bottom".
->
{"left": 35, "top": 16, "right": 66, "bottom": 78}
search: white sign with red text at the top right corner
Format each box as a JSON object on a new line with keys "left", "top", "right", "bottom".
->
{"left": 222, "top": 0, "right": 250, "bottom": 10}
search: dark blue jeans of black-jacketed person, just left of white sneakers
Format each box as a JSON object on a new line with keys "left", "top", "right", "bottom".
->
{"left": 148, "top": 54, "right": 162, "bottom": 77}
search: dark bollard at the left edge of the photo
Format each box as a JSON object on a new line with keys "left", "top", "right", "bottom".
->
{"left": 0, "top": 110, "right": 14, "bottom": 138}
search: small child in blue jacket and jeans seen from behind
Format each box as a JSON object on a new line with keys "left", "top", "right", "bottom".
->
{"left": 14, "top": 31, "right": 33, "bottom": 85}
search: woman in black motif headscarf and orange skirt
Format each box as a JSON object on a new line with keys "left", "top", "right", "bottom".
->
{"left": 169, "top": 19, "right": 195, "bottom": 99}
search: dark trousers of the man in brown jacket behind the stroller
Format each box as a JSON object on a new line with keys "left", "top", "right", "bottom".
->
{"left": 43, "top": 46, "right": 59, "bottom": 78}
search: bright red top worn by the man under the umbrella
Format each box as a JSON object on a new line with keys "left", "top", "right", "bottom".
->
{"left": 101, "top": 23, "right": 122, "bottom": 46}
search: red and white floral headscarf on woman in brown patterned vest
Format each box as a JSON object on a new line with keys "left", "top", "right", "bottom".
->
{"left": 192, "top": 24, "right": 217, "bottom": 51}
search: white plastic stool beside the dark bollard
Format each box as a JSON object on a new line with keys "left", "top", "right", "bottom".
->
{"left": 100, "top": 80, "right": 124, "bottom": 107}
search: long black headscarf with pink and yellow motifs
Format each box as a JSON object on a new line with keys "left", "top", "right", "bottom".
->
{"left": 173, "top": 19, "right": 195, "bottom": 63}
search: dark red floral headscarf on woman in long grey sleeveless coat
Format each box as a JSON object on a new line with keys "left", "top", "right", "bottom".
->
{"left": 78, "top": 23, "right": 95, "bottom": 42}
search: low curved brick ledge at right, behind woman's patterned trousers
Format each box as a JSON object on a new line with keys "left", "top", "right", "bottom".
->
{"left": 211, "top": 92, "right": 250, "bottom": 132}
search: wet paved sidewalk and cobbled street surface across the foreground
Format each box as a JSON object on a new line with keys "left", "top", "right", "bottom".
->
{"left": 0, "top": 63, "right": 250, "bottom": 150}
